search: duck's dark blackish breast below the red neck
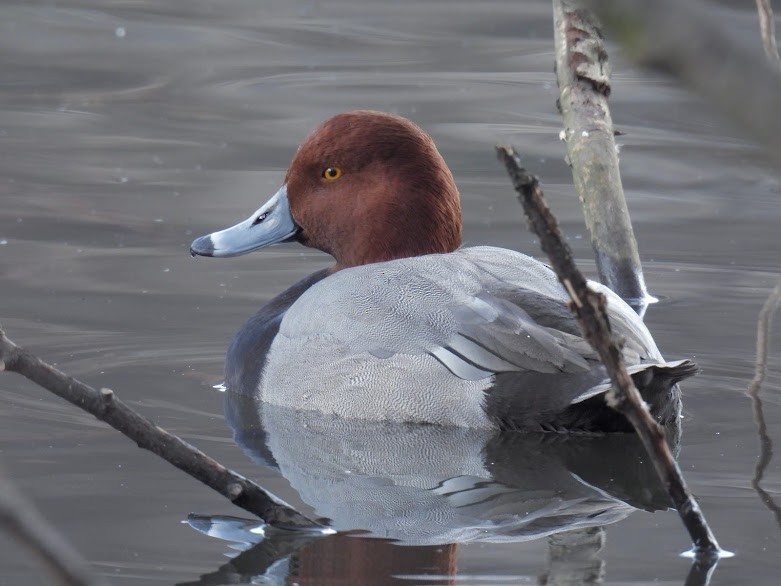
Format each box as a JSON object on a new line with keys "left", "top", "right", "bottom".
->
{"left": 225, "top": 269, "right": 329, "bottom": 395}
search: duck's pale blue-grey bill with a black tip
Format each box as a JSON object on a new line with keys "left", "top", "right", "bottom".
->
{"left": 190, "top": 186, "right": 299, "bottom": 257}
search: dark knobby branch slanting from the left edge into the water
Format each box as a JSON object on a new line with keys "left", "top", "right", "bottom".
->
{"left": 0, "top": 329, "right": 317, "bottom": 527}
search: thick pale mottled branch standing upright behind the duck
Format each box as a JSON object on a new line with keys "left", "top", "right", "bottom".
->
{"left": 553, "top": 0, "right": 647, "bottom": 313}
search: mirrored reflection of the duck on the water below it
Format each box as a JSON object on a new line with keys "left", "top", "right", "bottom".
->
{"left": 181, "top": 393, "right": 677, "bottom": 584}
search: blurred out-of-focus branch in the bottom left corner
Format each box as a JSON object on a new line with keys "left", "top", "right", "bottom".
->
{"left": 0, "top": 471, "right": 107, "bottom": 586}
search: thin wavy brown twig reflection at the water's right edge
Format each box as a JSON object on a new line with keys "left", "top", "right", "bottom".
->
{"left": 746, "top": 279, "right": 781, "bottom": 528}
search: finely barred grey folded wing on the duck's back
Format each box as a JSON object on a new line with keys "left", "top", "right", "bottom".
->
{"left": 280, "top": 255, "right": 632, "bottom": 380}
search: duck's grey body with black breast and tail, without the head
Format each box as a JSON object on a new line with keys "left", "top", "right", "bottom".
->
{"left": 226, "top": 247, "right": 696, "bottom": 431}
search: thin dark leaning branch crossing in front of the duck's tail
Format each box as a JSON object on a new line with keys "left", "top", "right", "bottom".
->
{"left": 496, "top": 146, "right": 721, "bottom": 560}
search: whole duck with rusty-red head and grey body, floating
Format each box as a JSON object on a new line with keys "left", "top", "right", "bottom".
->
{"left": 191, "top": 111, "right": 696, "bottom": 432}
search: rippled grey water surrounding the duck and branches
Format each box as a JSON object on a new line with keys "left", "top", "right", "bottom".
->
{"left": 0, "top": 0, "right": 781, "bottom": 584}
